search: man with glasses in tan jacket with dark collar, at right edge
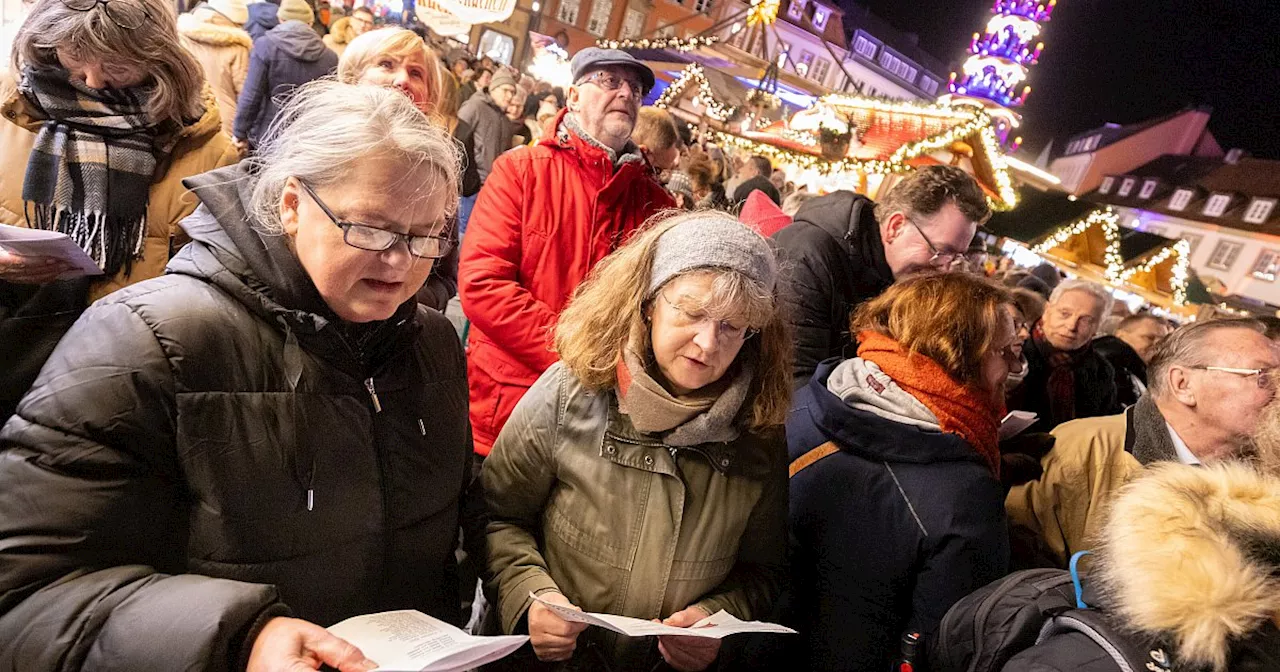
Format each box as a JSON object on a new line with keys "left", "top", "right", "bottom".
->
{"left": 1005, "top": 319, "right": 1280, "bottom": 567}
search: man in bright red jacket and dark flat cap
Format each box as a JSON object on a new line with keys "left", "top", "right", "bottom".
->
{"left": 458, "top": 47, "right": 675, "bottom": 456}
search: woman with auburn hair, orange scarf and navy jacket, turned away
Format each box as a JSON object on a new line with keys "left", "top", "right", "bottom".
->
{"left": 787, "top": 274, "right": 1020, "bottom": 672}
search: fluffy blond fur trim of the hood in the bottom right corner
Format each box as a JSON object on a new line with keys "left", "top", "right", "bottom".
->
{"left": 1094, "top": 463, "right": 1280, "bottom": 672}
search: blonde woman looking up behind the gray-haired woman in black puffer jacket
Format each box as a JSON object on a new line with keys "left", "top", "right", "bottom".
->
{"left": 338, "top": 28, "right": 468, "bottom": 311}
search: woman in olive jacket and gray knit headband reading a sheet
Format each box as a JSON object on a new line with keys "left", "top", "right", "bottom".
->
{"left": 483, "top": 211, "right": 790, "bottom": 671}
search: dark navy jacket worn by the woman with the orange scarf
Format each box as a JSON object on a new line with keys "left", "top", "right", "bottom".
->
{"left": 787, "top": 360, "right": 1009, "bottom": 672}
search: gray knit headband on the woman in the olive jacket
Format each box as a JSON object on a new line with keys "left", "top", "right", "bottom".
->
{"left": 649, "top": 211, "right": 778, "bottom": 296}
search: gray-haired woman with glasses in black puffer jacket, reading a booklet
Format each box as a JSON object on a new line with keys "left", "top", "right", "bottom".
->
{"left": 0, "top": 82, "right": 483, "bottom": 672}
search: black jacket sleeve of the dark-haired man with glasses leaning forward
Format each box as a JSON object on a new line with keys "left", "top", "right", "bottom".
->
{"left": 773, "top": 223, "right": 849, "bottom": 389}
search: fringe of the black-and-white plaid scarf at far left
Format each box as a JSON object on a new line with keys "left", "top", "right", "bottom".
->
{"left": 28, "top": 204, "right": 147, "bottom": 276}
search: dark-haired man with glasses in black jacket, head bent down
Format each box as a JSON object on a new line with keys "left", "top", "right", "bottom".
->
{"left": 773, "top": 165, "right": 991, "bottom": 388}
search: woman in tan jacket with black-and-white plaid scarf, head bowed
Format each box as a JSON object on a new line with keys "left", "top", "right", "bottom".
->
{"left": 0, "top": 0, "right": 238, "bottom": 424}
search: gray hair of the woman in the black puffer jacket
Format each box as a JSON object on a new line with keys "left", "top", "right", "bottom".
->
{"left": 250, "top": 79, "right": 462, "bottom": 233}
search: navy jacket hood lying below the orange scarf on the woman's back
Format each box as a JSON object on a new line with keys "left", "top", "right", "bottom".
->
{"left": 788, "top": 360, "right": 987, "bottom": 468}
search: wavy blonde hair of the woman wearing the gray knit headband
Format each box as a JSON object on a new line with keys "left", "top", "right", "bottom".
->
{"left": 556, "top": 210, "right": 791, "bottom": 433}
